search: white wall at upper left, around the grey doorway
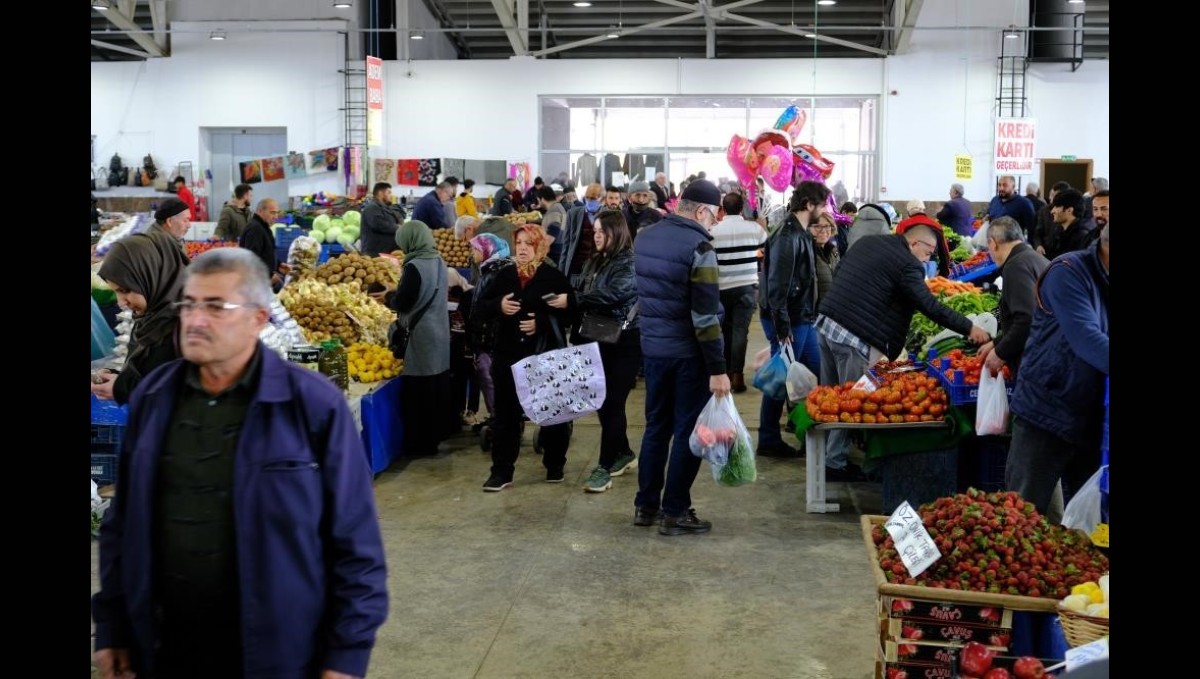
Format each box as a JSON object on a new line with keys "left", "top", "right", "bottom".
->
{"left": 91, "top": 22, "right": 344, "bottom": 196}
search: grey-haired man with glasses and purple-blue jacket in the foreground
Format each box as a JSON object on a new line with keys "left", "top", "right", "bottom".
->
{"left": 92, "top": 248, "right": 388, "bottom": 679}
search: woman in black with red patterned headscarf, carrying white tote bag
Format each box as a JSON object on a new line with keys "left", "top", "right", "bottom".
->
{"left": 475, "top": 224, "right": 575, "bottom": 492}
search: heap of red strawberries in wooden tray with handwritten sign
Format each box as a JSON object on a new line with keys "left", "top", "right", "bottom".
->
{"left": 871, "top": 488, "right": 1109, "bottom": 599}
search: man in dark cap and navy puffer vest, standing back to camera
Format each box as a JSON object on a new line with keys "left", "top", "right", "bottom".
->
{"left": 634, "top": 179, "right": 730, "bottom": 535}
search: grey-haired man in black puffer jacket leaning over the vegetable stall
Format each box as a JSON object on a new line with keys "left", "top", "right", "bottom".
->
{"left": 816, "top": 224, "right": 989, "bottom": 481}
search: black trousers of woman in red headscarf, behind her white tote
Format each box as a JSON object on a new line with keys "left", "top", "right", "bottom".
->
{"left": 492, "top": 354, "right": 571, "bottom": 480}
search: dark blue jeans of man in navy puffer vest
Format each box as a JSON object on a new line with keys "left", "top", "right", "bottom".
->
{"left": 634, "top": 356, "right": 712, "bottom": 517}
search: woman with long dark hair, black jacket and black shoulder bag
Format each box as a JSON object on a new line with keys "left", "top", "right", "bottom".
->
{"left": 577, "top": 210, "right": 642, "bottom": 493}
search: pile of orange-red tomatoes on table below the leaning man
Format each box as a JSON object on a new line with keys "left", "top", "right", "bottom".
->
{"left": 804, "top": 372, "right": 948, "bottom": 425}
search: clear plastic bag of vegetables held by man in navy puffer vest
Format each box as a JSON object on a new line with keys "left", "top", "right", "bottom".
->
{"left": 688, "top": 395, "right": 757, "bottom": 486}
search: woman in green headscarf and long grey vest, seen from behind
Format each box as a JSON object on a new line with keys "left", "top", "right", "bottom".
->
{"left": 389, "top": 220, "right": 458, "bottom": 456}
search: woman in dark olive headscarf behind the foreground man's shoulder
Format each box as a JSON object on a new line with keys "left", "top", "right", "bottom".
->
{"left": 91, "top": 234, "right": 186, "bottom": 405}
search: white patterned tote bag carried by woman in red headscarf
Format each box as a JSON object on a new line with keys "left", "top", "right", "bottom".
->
{"left": 512, "top": 342, "right": 606, "bottom": 427}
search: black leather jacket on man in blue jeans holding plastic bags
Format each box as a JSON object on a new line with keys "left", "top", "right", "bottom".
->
{"left": 758, "top": 215, "right": 817, "bottom": 338}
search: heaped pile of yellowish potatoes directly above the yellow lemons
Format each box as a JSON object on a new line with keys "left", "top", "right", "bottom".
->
{"left": 280, "top": 278, "right": 396, "bottom": 345}
